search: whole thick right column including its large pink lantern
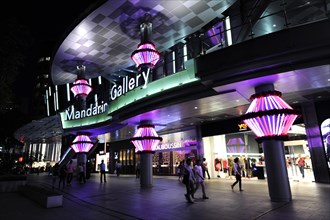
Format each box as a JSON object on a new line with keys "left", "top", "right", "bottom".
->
{"left": 243, "top": 84, "right": 298, "bottom": 202}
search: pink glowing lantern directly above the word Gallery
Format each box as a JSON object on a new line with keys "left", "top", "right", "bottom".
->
{"left": 131, "top": 43, "right": 160, "bottom": 67}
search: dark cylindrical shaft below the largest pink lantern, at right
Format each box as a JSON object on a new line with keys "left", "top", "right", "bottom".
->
{"left": 262, "top": 140, "right": 292, "bottom": 202}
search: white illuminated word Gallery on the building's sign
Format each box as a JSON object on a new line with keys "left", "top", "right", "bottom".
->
{"left": 110, "top": 69, "right": 150, "bottom": 100}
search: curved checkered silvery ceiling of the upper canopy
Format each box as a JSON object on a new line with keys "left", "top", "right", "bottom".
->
{"left": 52, "top": 0, "right": 235, "bottom": 85}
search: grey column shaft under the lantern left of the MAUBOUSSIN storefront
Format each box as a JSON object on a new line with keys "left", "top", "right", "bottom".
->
{"left": 140, "top": 152, "right": 153, "bottom": 188}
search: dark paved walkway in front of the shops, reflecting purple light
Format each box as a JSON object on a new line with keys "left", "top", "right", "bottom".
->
{"left": 0, "top": 174, "right": 330, "bottom": 220}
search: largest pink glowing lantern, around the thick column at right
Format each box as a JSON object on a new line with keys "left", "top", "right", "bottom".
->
{"left": 242, "top": 91, "right": 298, "bottom": 141}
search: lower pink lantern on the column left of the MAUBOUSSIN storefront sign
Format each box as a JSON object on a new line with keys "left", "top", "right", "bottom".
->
{"left": 131, "top": 125, "right": 162, "bottom": 152}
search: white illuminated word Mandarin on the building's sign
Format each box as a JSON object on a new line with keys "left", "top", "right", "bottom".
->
{"left": 65, "top": 102, "right": 108, "bottom": 121}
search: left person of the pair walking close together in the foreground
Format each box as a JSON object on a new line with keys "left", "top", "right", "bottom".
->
{"left": 182, "top": 158, "right": 196, "bottom": 203}
